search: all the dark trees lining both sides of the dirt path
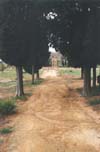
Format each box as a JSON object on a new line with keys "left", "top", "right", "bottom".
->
{"left": 0, "top": 0, "right": 100, "bottom": 96}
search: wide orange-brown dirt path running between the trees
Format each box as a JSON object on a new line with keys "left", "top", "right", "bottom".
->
{"left": 2, "top": 71, "right": 100, "bottom": 152}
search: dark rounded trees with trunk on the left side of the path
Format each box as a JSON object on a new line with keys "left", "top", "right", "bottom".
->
{"left": 0, "top": 0, "right": 49, "bottom": 96}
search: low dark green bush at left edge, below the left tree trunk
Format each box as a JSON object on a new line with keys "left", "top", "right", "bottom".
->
{"left": 0, "top": 100, "right": 16, "bottom": 115}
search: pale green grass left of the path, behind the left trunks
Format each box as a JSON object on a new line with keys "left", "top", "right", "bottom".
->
{"left": 0, "top": 67, "right": 43, "bottom": 101}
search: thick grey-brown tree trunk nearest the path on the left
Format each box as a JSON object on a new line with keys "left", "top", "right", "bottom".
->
{"left": 16, "top": 66, "right": 24, "bottom": 97}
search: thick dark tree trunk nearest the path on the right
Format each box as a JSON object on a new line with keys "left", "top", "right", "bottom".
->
{"left": 83, "top": 67, "right": 91, "bottom": 96}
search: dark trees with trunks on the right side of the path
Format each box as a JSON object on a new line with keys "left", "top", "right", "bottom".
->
{"left": 45, "top": 0, "right": 100, "bottom": 96}
